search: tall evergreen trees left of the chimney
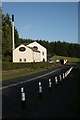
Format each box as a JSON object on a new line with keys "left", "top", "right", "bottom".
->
{"left": 2, "top": 13, "right": 12, "bottom": 60}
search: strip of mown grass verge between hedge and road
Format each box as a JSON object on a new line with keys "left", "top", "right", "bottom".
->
{"left": 2, "top": 63, "right": 61, "bottom": 80}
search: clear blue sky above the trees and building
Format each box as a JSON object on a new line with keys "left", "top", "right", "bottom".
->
{"left": 2, "top": 2, "right": 78, "bottom": 43}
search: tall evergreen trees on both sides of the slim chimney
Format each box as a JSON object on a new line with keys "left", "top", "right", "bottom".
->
{"left": 2, "top": 13, "right": 20, "bottom": 61}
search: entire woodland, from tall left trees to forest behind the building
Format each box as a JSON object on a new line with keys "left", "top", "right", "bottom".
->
{"left": 2, "top": 13, "right": 80, "bottom": 61}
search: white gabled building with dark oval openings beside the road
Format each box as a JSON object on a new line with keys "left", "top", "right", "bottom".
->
{"left": 13, "top": 42, "right": 47, "bottom": 62}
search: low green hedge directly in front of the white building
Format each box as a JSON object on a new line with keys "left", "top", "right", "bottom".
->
{"left": 2, "top": 62, "right": 51, "bottom": 70}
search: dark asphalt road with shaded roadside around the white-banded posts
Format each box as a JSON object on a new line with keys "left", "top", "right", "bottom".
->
{"left": 0, "top": 65, "right": 80, "bottom": 119}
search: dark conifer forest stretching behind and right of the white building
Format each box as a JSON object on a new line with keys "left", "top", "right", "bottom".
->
{"left": 20, "top": 38, "right": 80, "bottom": 58}
